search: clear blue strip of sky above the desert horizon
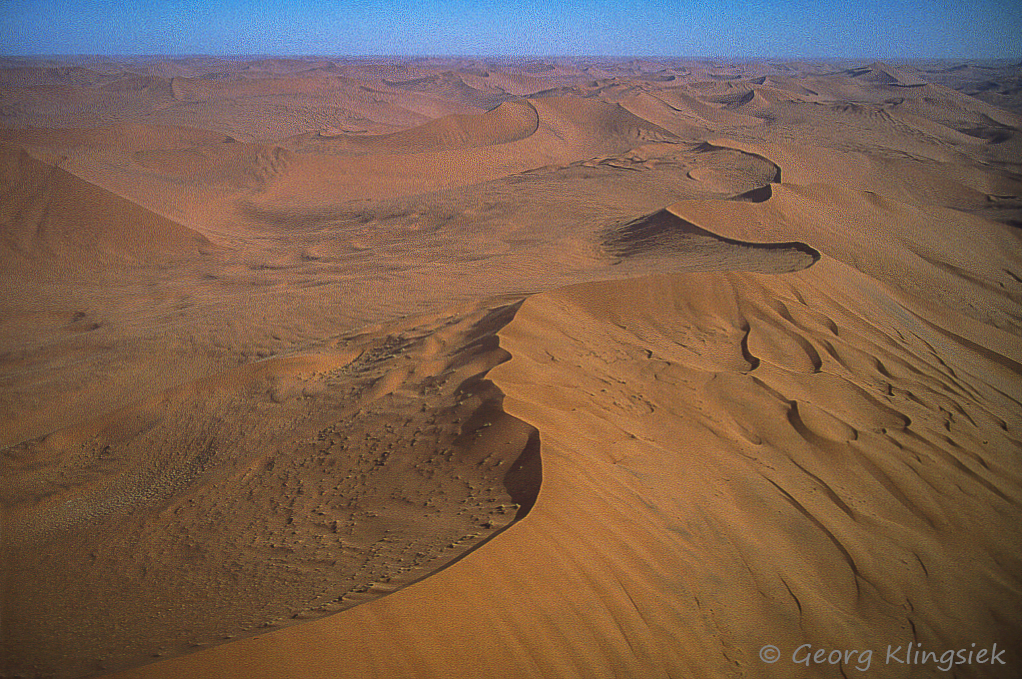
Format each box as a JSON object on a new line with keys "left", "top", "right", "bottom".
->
{"left": 0, "top": 0, "right": 1022, "bottom": 58}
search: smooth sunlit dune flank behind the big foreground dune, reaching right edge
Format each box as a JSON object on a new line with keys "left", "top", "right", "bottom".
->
{"left": 669, "top": 179, "right": 1022, "bottom": 345}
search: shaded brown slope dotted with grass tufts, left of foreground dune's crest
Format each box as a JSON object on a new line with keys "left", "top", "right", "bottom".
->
{"left": 0, "top": 308, "right": 542, "bottom": 677}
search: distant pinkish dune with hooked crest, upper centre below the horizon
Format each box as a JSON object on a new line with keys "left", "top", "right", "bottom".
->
{"left": 243, "top": 97, "right": 677, "bottom": 209}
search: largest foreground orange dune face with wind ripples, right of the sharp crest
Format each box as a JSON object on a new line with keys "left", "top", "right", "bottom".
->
{"left": 96, "top": 249, "right": 1020, "bottom": 677}
